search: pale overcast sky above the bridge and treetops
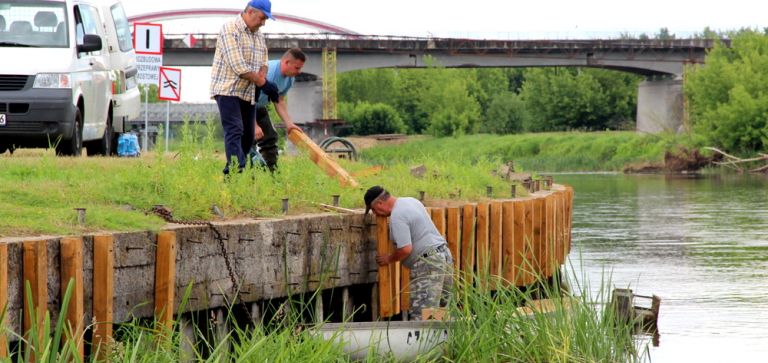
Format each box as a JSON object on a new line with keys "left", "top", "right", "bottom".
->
{"left": 123, "top": 0, "right": 768, "bottom": 39}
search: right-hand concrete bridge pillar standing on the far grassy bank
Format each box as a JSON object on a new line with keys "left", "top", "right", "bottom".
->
{"left": 637, "top": 78, "right": 684, "bottom": 133}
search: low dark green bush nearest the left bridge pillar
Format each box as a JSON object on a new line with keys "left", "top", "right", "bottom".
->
{"left": 342, "top": 102, "right": 406, "bottom": 135}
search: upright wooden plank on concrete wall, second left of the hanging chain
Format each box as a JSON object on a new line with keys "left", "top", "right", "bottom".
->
{"left": 93, "top": 234, "right": 115, "bottom": 360}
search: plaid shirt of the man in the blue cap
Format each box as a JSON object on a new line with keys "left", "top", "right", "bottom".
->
{"left": 211, "top": 15, "right": 269, "bottom": 104}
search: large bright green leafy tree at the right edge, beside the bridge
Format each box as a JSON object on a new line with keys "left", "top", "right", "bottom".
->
{"left": 685, "top": 31, "right": 768, "bottom": 153}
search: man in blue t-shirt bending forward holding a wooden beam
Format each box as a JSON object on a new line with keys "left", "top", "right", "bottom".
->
{"left": 249, "top": 48, "right": 307, "bottom": 171}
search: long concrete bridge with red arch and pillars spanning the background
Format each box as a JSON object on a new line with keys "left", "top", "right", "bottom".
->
{"left": 129, "top": 9, "right": 727, "bottom": 132}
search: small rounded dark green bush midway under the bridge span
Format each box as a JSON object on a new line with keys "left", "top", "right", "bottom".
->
{"left": 482, "top": 91, "right": 530, "bottom": 134}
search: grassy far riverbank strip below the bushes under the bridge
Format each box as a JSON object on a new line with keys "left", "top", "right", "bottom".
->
{"left": 361, "top": 131, "right": 694, "bottom": 172}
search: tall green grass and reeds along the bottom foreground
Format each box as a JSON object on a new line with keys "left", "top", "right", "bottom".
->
{"left": 1, "top": 268, "right": 648, "bottom": 363}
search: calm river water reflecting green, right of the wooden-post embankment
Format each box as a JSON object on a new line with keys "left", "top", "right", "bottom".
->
{"left": 555, "top": 174, "right": 768, "bottom": 362}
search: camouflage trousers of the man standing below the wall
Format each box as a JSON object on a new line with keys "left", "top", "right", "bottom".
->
{"left": 409, "top": 245, "right": 453, "bottom": 320}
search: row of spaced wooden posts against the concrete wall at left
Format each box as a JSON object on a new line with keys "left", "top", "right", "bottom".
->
{"left": 0, "top": 231, "right": 176, "bottom": 360}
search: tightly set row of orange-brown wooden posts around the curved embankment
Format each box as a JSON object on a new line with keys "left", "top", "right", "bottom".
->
{"left": 376, "top": 185, "right": 573, "bottom": 318}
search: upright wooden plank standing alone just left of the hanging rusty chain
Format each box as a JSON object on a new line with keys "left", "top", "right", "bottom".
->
{"left": 155, "top": 231, "right": 176, "bottom": 332}
